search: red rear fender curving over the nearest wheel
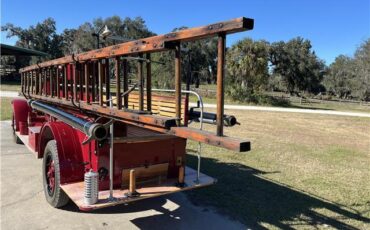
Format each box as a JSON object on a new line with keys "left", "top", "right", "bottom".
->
{"left": 38, "top": 121, "right": 85, "bottom": 184}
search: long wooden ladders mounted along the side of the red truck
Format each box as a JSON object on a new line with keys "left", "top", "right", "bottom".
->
{"left": 20, "top": 17, "right": 253, "bottom": 152}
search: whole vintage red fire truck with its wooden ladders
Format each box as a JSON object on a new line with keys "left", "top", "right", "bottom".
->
{"left": 12, "top": 17, "right": 253, "bottom": 211}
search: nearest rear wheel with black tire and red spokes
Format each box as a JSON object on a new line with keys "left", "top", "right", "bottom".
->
{"left": 42, "top": 140, "right": 69, "bottom": 208}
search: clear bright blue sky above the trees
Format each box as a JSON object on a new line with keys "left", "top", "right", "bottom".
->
{"left": 1, "top": 0, "right": 370, "bottom": 64}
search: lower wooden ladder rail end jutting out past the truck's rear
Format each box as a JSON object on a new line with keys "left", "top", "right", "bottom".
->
{"left": 171, "top": 127, "right": 251, "bottom": 152}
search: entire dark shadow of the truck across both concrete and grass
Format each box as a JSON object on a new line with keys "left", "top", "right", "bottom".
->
{"left": 59, "top": 153, "right": 370, "bottom": 229}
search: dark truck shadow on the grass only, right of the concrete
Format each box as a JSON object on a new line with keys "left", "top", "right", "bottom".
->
{"left": 187, "top": 154, "right": 370, "bottom": 229}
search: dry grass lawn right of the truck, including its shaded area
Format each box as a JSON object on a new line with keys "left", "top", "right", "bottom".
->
{"left": 187, "top": 110, "right": 370, "bottom": 229}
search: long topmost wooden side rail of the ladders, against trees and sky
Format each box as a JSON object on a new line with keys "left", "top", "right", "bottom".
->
{"left": 20, "top": 17, "right": 254, "bottom": 72}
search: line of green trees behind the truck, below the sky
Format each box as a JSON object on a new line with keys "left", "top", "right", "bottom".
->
{"left": 1, "top": 16, "right": 370, "bottom": 100}
